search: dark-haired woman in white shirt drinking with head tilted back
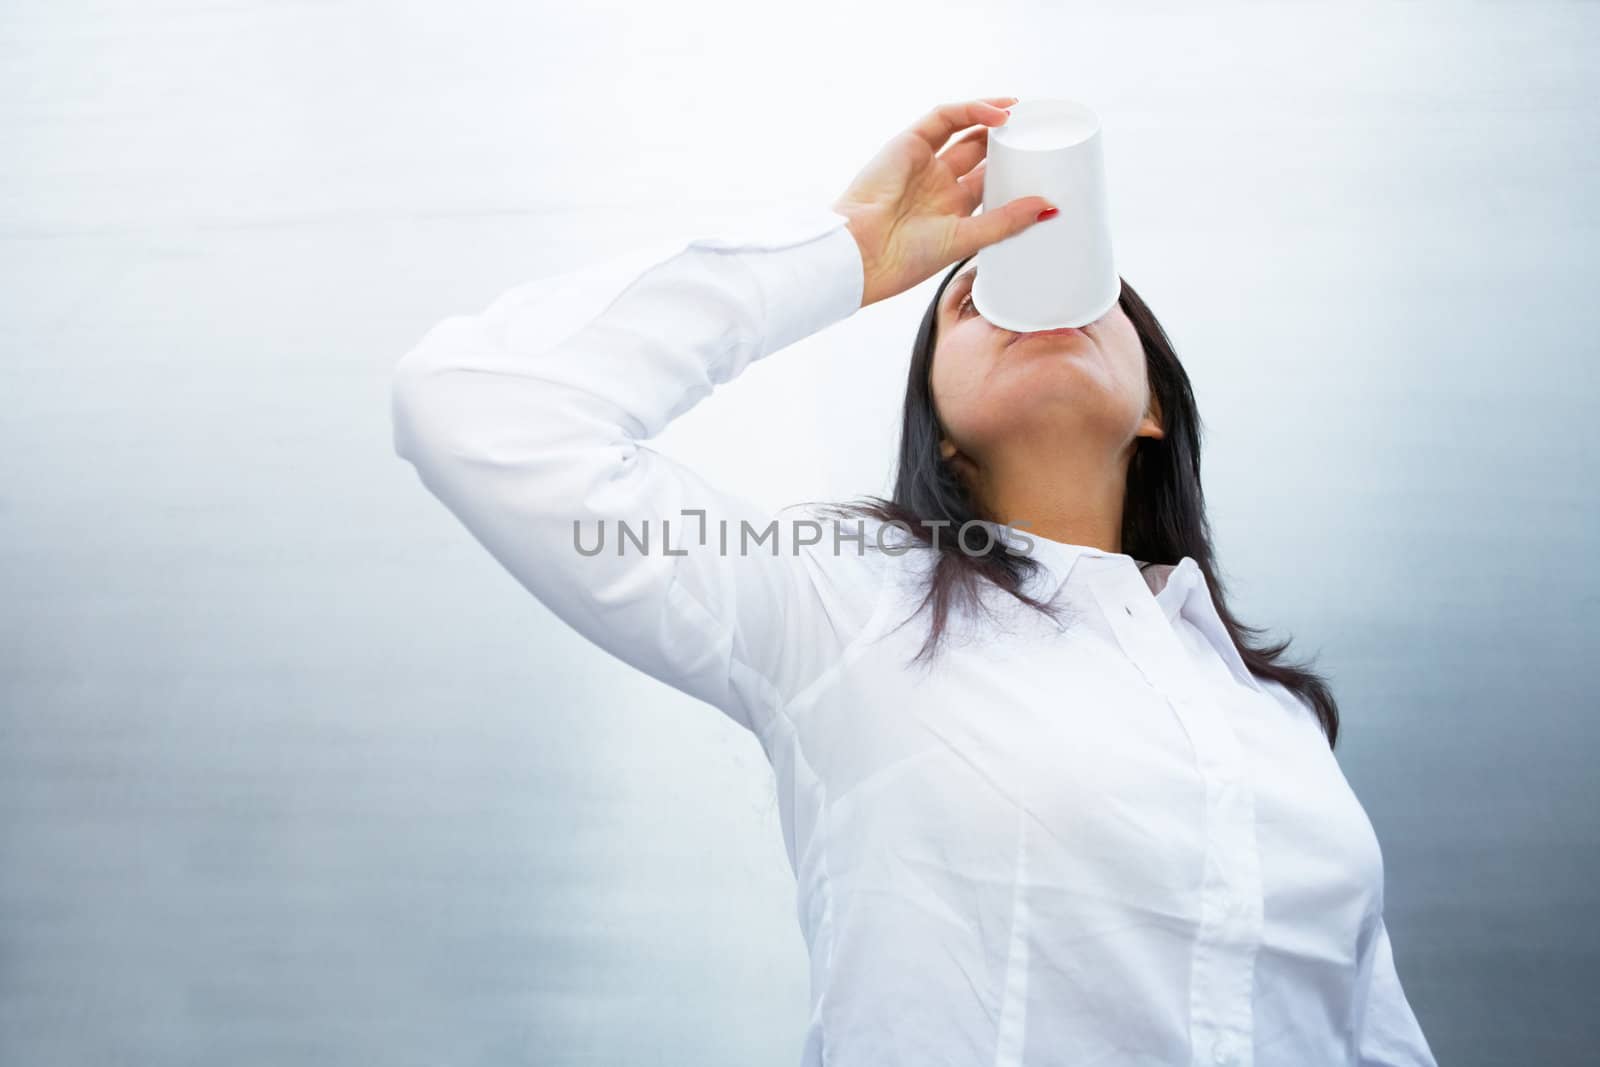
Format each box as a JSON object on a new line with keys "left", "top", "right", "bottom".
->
{"left": 394, "top": 98, "right": 1434, "bottom": 1067}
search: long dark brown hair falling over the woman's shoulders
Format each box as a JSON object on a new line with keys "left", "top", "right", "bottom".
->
{"left": 812, "top": 259, "right": 1339, "bottom": 749}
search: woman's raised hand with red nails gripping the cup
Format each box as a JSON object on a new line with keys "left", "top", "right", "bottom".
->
{"left": 832, "top": 96, "right": 1054, "bottom": 307}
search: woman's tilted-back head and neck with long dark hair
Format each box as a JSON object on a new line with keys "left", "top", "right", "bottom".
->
{"left": 806, "top": 261, "right": 1339, "bottom": 747}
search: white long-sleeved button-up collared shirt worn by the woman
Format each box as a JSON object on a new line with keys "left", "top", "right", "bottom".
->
{"left": 394, "top": 204, "right": 1434, "bottom": 1067}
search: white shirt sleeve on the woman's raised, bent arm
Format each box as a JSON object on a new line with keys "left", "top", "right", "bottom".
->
{"left": 392, "top": 210, "right": 883, "bottom": 741}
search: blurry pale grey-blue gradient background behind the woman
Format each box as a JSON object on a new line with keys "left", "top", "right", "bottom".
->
{"left": 0, "top": 0, "right": 1600, "bottom": 1067}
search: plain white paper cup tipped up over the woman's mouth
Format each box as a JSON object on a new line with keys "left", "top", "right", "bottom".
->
{"left": 973, "top": 98, "right": 1122, "bottom": 333}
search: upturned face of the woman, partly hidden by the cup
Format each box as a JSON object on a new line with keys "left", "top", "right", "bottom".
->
{"left": 931, "top": 266, "right": 1162, "bottom": 469}
